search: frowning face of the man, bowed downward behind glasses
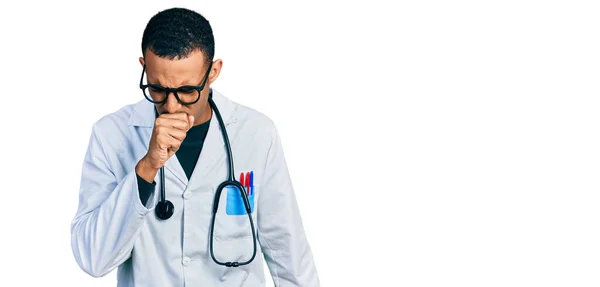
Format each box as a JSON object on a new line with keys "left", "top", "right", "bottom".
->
{"left": 140, "top": 50, "right": 221, "bottom": 125}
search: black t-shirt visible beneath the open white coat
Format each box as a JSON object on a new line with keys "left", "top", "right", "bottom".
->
{"left": 136, "top": 120, "right": 210, "bottom": 205}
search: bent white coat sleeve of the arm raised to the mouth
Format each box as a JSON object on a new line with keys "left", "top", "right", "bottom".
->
{"left": 71, "top": 124, "right": 154, "bottom": 277}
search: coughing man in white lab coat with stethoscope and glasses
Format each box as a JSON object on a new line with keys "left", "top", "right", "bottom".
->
{"left": 71, "top": 8, "right": 319, "bottom": 286}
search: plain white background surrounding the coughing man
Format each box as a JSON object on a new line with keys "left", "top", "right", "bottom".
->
{"left": 0, "top": 1, "right": 600, "bottom": 286}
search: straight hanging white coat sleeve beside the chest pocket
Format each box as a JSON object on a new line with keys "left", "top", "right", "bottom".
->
{"left": 257, "top": 126, "right": 320, "bottom": 287}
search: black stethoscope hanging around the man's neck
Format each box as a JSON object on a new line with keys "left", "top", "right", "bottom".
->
{"left": 155, "top": 93, "right": 256, "bottom": 267}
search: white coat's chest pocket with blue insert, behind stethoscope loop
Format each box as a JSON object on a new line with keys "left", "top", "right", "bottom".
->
{"left": 214, "top": 185, "right": 260, "bottom": 242}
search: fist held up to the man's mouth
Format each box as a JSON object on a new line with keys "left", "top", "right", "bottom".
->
{"left": 136, "top": 113, "right": 194, "bottom": 182}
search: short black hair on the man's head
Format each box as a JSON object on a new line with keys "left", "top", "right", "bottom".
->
{"left": 142, "top": 8, "right": 215, "bottom": 63}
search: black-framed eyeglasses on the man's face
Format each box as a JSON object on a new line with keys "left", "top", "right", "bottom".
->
{"left": 140, "top": 62, "right": 212, "bottom": 105}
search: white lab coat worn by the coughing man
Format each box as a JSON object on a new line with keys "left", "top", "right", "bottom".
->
{"left": 71, "top": 90, "right": 319, "bottom": 287}
